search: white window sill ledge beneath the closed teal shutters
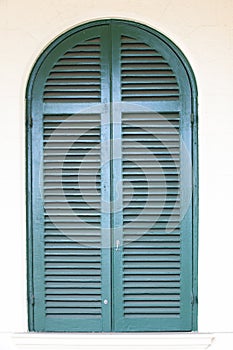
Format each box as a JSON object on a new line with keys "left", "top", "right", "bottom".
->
{"left": 9, "top": 332, "right": 214, "bottom": 350}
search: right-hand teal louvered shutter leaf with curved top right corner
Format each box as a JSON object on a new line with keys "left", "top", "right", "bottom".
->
{"left": 113, "top": 25, "right": 192, "bottom": 331}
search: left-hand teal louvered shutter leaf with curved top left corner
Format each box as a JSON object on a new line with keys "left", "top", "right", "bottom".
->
{"left": 32, "top": 23, "right": 110, "bottom": 331}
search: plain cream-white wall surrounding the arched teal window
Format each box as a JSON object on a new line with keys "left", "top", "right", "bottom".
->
{"left": 0, "top": 0, "right": 233, "bottom": 349}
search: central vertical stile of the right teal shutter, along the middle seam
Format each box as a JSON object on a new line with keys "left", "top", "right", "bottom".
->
{"left": 111, "top": 24, "right": 123, "bottom": 332}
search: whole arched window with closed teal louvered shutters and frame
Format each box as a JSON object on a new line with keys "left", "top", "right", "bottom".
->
{"left": 27, "top": 20, "right": 197, "bottom": 332}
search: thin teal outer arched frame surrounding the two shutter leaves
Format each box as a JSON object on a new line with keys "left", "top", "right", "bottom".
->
{"left": 26, "top": 19, "right": 199, "bottom": 331}
